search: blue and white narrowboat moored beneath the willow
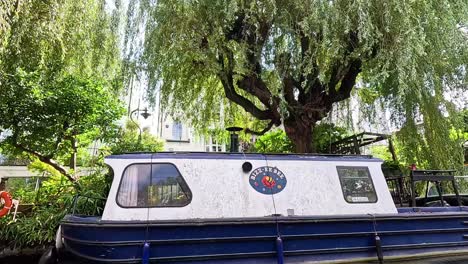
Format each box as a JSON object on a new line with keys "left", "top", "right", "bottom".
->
{"left": 57, "top": 153, "right": 468, "bottom": 263}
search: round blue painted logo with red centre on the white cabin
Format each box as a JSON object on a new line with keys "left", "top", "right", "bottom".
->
{"left": 249, "top": 166, "right": 287, "bottom": 194}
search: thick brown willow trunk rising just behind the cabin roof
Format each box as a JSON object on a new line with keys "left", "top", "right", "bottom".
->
{"left": 284, "top": 119, "right": 315, "bottom": 153}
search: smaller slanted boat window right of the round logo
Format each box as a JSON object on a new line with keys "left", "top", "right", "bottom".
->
{"left": 337, "top": 167, "right": 377, "bottom": 203}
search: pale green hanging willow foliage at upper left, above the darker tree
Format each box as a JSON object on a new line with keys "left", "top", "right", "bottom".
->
{"left": 0, "top": 0, "right": 120, "bottom": 80}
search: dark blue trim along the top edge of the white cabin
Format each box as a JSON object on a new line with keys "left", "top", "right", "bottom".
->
{"left": 106, "top": 152, "right": 382, "bottom": 162}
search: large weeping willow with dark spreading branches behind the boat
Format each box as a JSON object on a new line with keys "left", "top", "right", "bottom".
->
{"left": 136, "top": 0, "right": 468, "bottom": 157}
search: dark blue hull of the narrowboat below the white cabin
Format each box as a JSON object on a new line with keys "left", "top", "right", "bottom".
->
{"left": 61, "top": 207, "right": 468, "bottom": 263}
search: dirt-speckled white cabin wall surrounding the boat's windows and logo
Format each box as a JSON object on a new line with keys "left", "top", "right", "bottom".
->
{"left": 103, "top": 159, "right": 397, "bottom": 220}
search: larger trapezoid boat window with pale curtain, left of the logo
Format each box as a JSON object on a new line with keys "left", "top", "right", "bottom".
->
{"left": 117, "top": 163, "right": 192, "bottom": 207}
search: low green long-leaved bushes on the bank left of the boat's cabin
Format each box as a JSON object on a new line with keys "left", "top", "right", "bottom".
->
{"left": 0, "top": 171, "right": 110, "bottom": 248}
